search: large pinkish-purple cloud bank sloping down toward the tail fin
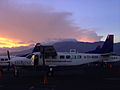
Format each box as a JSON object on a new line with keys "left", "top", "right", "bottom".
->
{"left": 0, "top": 0, "right": 102, "bottom": 42}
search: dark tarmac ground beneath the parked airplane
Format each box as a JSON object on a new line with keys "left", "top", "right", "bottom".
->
{"left": 0, "top": 67, "right": 120, "bottom": 90}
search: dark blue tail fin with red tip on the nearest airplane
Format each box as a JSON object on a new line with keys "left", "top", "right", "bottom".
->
{"left": 87, "top": 35, "right": 114, "bottom": 54}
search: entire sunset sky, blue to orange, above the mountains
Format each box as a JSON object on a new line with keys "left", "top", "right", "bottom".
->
{"left": 0, "top": 0, "right": 120, "bottom": 47}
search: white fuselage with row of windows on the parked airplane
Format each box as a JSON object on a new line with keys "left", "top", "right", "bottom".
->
{"left": 0, "top": 52, "right": 120, "bottom": 66}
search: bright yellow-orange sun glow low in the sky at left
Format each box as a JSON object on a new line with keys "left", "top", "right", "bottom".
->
{"left": 0, "top": 37, "right": 30, "bottom": 48}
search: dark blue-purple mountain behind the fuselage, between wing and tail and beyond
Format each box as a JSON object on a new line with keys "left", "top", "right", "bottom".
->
{"left": 54, "top": 41, "right": 120, "bottom": 55}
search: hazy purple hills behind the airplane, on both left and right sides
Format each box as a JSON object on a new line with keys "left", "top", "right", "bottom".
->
{"left": 0, "top": 41, "right": 120, "bottom": 55}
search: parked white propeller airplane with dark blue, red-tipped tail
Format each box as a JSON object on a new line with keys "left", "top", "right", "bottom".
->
{"left": 0, "top": 35, "right": 120, "bottom": 76}
